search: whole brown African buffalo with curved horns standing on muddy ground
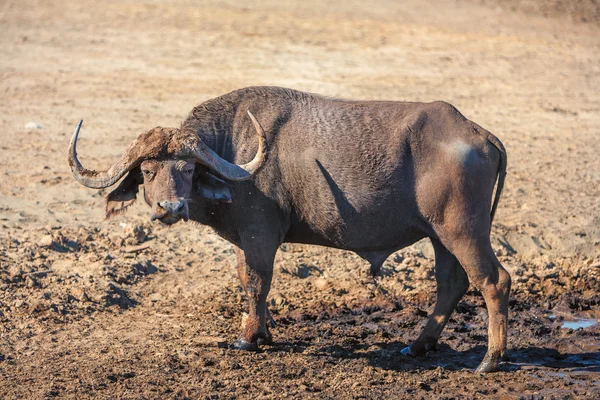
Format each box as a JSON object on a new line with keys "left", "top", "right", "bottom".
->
{"left": 69, "top": 87, "right": 511, "bottom": 372}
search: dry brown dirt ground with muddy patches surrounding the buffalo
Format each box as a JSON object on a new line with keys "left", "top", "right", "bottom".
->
{"left": 0, "top": 0, "right": 600, "bottom": 399}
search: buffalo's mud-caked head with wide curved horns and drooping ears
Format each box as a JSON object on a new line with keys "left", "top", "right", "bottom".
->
{"left": 69, "top": 111, "right": 267, "bottom": 224}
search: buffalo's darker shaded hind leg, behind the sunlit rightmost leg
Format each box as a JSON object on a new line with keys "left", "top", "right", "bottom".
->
{"left": 402, "top": 238, "right": 469, "bottom": 356}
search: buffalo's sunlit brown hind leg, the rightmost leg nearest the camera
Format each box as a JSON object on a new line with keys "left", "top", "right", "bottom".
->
{"left": 447, "top": 235, "right": 511, "bottom": 372}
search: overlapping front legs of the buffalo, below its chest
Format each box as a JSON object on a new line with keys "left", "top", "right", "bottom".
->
{"left": 231, "top": 241, "right": 276, "bottom": 351}
